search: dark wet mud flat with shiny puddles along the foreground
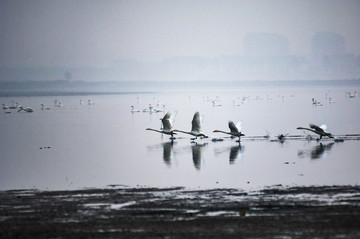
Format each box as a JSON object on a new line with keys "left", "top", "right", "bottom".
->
{"left": 0, "top": 186, "right": 360, "bottom": 238}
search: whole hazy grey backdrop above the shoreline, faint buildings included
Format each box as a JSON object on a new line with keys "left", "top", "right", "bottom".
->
{"left": 0, "top": 0, "right": 360, "bottom": 82}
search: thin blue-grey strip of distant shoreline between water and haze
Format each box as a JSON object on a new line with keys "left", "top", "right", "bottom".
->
{"left": 0, "top": 79, "right": 360, "bottom": 97}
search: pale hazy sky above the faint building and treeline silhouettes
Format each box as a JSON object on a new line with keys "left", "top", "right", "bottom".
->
{"left": 0, "top": 0, "right": 360, "bottom": 67}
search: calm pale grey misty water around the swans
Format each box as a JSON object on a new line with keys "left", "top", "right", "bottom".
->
{"left": 0, "top": 86, "right": 360, "bottom": 190}
